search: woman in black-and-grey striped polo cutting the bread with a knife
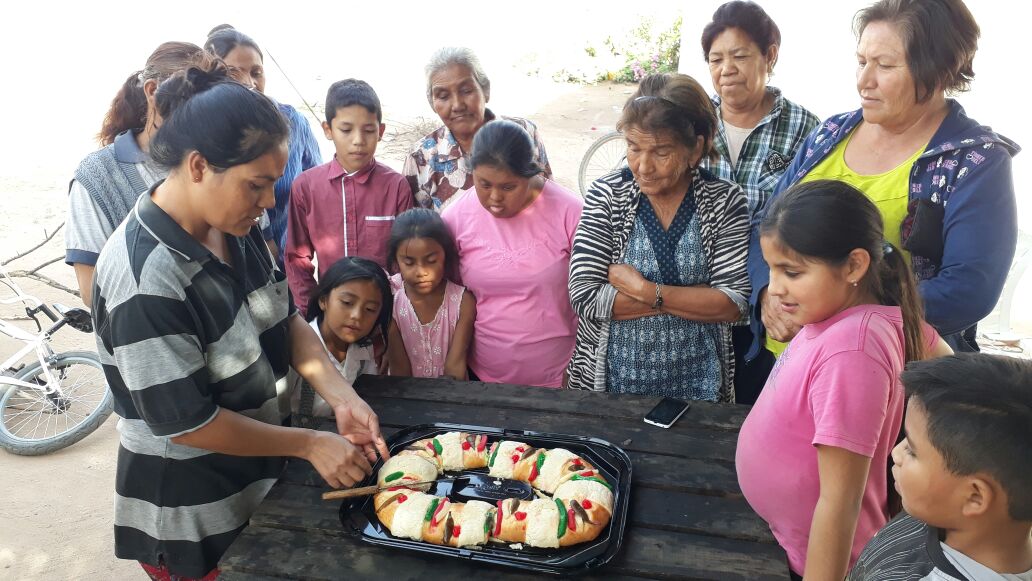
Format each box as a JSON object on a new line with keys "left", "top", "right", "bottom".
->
{"left": 93, "top": 64, "right": 389, "bottom": 580}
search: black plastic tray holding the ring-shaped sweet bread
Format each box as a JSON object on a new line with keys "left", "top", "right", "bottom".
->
{"left": 340, "top": 423, "right": 631, "bottom": 575}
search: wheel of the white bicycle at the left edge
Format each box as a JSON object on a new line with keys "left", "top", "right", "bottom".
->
{"left": 0, "top": 351, "right": 111, "bottom": 456}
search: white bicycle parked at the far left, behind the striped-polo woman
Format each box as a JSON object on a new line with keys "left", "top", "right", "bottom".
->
{"left": 0, "top": 265, "right": 111, "bottom": 456}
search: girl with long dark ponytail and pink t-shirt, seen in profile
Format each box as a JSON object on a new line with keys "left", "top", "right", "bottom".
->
{"left": 735, "top": 181, "right": 949, "bottom": 579}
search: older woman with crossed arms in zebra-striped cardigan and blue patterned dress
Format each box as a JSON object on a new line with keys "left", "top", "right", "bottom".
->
{"left": 569, "top": 73, "right": 749, "bottom": 401}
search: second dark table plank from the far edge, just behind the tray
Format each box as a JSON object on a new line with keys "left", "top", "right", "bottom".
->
{"left": 365, "top": 396, "right": 738, "bottom": 464}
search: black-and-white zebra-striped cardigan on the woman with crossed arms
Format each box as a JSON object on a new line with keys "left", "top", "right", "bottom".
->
{"left": 569, "top": 167, "right": 749, "bottom": 401}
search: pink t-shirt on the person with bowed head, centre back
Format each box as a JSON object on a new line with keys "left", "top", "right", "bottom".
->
{"left": 441, "top": 181, "right": 583, "bottom": 387}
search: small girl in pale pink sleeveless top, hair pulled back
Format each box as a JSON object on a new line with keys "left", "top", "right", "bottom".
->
{"left": 387, "top": 208, "right": 477, "bottom": 380}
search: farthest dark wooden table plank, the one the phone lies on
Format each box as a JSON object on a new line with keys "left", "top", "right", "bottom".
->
{"left": 355, "top": 376, "right": 749, "bottom": 431}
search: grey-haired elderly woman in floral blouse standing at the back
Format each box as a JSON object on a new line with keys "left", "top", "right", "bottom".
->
{"left": 401, "top": 46, "right": 552, "bottom": 212}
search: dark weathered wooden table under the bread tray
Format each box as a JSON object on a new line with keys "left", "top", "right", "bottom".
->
{"left": 219, "top": 376, "right": 788, "bottom": 581}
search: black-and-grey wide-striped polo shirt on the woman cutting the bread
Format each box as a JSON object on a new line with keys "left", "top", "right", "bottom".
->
{"left": 93, "top": 187, "right": 294, "bottom": 577}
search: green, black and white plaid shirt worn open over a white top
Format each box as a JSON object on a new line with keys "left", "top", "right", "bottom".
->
{"left": 702, "top": 87, "right": 820, "bottom": 216}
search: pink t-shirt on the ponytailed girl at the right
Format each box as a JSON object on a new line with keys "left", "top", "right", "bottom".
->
{"left": 735, "top": 304, "right": 938, "bottom": 574}
